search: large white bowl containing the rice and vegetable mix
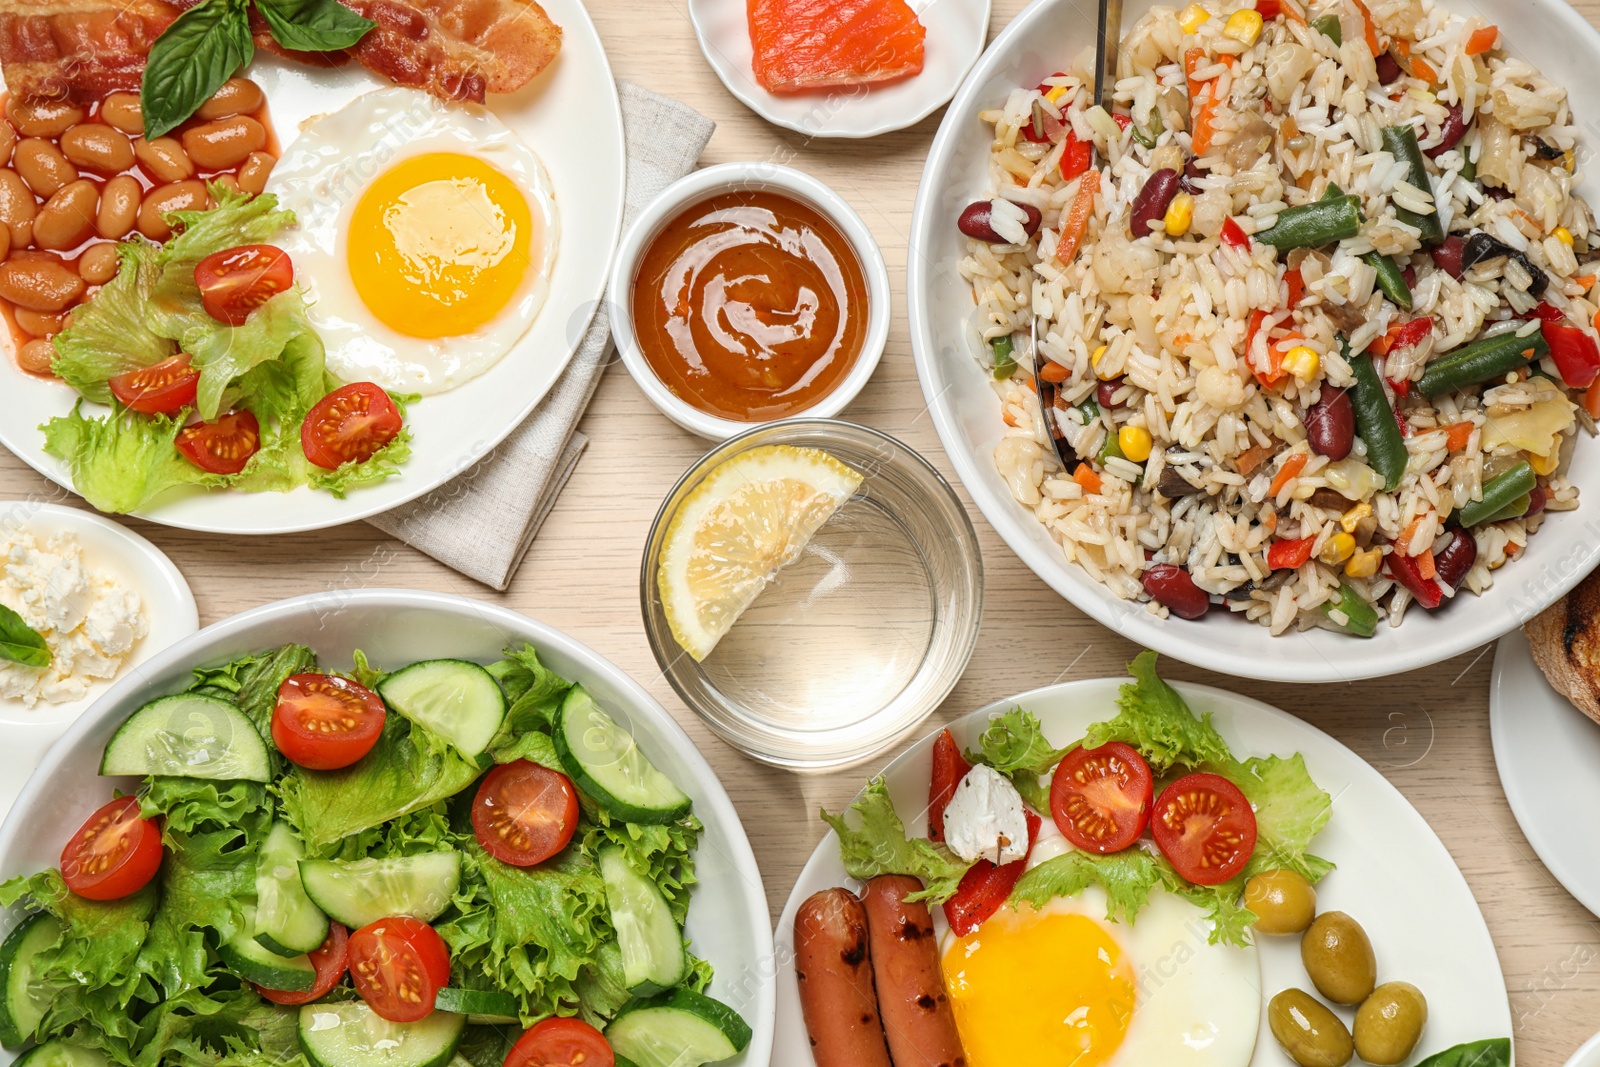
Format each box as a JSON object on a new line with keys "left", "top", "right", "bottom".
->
{"left": 907, "top": 0, "right": 1600, "bottom": 681}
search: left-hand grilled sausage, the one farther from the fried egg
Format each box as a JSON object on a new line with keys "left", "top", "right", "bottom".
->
{"left": 795, "top": 889, "right": 890, "bottom": 1067}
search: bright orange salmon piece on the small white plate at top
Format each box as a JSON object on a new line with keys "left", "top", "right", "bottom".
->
{"left": 746, "top": 0, "right": 926, "bottom": 93}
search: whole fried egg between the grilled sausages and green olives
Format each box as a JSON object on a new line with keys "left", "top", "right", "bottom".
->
{"left": 942, "top": 837, "right": 1261, "bottom": 1067}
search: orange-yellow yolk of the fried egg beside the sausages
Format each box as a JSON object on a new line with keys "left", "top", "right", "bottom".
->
{"left": 944, "top": 907, "right": 1136, "bottom": 1067}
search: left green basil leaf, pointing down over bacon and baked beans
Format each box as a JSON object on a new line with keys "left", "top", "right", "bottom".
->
{"left": 139, "top": 0, "right": 256, "bottom": 141}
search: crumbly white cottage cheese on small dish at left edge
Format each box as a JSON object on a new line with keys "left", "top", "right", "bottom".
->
{"left": 0, "top": 530, "right": 149, "bottom": 707}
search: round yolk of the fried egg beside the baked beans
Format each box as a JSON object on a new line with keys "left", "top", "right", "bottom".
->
{"left": 347, "top": 152, "right": 539, "bottom": 338}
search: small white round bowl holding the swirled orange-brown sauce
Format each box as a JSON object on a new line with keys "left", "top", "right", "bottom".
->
{"left": 605, "top": 163, "right": 891, "bottom": 442}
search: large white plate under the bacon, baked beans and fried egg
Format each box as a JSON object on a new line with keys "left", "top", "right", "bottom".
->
{"left": 0, "top": 0, "right": 626, "bottom": 534}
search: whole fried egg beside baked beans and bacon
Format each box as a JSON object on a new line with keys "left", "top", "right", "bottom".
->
{"left": 267, "top": 88, "right": 558, "bottom": 395}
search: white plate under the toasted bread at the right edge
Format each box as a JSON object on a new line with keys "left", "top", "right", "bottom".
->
{"left": 1490, "top": 630, "right": 1600, "bottom": 921}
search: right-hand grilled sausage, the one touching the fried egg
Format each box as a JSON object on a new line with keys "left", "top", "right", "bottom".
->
{"left": 861, "top": 875, "right": 966, "bottom": 1067}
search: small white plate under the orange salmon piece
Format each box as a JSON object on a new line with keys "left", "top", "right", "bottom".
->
{"left": 690, "top": 0, "right": 989, "bottom": 138}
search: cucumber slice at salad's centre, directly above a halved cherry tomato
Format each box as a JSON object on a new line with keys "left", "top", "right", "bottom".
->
{"left": 299, "top": 853, "right": 461, "bottom": 931}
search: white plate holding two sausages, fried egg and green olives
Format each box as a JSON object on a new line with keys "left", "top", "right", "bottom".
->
{"left": 773, "top": 678, "right": 1510, "bottom": 1067}
